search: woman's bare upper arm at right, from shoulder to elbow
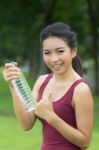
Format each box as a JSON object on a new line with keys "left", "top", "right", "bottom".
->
{"left": 73, "top": 82, "right": 94, "bottom": 145}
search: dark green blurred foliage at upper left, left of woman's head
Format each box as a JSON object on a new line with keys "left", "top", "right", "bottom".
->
{"left": 0, "top": 0, "right": 42, "bottom": 63}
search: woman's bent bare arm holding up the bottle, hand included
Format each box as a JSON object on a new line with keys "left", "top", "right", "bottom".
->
{"left": 3, "top": 64, "right": 37, "bottom": 130}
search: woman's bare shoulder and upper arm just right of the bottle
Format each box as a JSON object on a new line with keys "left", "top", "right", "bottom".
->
{"left": 32, "top": 74, "right": 49, "bottom": 99}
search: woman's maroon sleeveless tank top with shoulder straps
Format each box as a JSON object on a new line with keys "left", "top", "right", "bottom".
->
{"left": 38, "top": 74, "right": 85, "bottom": 150}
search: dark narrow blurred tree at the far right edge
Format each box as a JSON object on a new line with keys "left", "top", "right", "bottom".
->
{"left": 86, "top": 0, "right": 99, "bottom": 94}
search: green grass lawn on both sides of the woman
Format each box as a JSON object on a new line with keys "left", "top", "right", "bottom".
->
{"left": 0, "top": 69, "right": 99, "bottom": 150}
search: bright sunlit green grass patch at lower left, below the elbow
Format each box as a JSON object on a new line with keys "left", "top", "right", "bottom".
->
{"left": 0, "top": 117, "right": 41, "bottom": 150}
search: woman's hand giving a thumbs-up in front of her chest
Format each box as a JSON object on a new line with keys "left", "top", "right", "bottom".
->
{"left": 35, "top": 92, "right": 54, "bottom": 121}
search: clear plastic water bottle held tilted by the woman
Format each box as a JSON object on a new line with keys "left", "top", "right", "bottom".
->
{"left": 11, "top": 62, "right": 36, "bottom": 112}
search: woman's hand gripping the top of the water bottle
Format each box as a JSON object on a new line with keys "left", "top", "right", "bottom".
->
{"left": 3, "top": 63, "right": 21, "bottom": 85}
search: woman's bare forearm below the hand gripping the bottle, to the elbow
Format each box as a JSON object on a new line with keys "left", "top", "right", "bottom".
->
{"left": 10, "top": 87, "right": 36, "bottom": 131}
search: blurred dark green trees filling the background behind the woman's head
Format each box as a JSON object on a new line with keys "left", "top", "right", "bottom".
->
{"left": 0, "top": 0, "right": 99, "bottom": 94}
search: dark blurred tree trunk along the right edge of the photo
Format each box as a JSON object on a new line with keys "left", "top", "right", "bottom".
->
{"left": 86, "top": 0, "right": 99, "bottom": 95}
